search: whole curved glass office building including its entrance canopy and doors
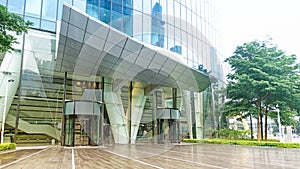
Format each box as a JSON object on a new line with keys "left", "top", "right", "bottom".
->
{"left": 0, "top": 0, "right": 224, "bottom": 146}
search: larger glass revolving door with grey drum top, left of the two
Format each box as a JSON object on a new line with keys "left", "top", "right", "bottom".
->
{"left": 64, "top": 101, "right": 101, "bottom": 146}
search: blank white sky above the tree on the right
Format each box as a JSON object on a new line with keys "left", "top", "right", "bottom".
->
{"left": 215, "top": 0, "right": 300, "bottom": 62}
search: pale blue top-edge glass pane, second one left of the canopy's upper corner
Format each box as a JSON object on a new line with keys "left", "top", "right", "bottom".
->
{"left": 25, "top": 0, "right": 42, "bottom": 18}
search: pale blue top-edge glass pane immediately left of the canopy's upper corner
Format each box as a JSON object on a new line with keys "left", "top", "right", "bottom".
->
{"left": 42, "top": 0, "right": 57, "bottom": 21}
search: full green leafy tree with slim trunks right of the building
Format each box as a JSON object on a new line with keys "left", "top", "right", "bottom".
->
{"left": 225, "top": 40, "right": 299, "bottom": 140}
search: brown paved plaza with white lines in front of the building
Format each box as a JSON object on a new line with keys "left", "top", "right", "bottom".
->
{"left": 0, "top": 144, "right": 300, "bottom": 169}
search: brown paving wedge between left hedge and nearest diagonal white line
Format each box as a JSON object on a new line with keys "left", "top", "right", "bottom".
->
{"left": 0, "top": 149, "right": 41, "bottom": 165}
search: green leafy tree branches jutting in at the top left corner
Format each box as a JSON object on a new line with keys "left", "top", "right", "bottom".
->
{"left": 0, "top": 5, "right": 32, "bottom": 53}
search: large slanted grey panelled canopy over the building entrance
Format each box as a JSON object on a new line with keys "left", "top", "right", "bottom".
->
{"left": 56, "top": 4, "right": 210, "bottom": 91}
